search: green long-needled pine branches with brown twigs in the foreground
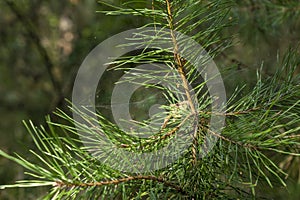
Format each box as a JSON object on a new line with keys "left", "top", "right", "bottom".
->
{"left": 0, "top": 0, "right": 300, "bottom": 199}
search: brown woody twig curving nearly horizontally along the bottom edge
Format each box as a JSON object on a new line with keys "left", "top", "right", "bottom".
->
{"left": 55, "top": 175, "right": 187, "bottom": 195}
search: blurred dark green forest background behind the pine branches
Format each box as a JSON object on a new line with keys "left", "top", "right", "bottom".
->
{"left": 0, "top": 0, "right": 300, "bottom": 199}
